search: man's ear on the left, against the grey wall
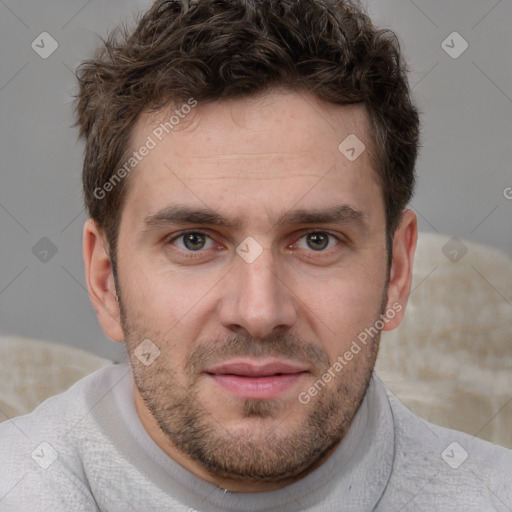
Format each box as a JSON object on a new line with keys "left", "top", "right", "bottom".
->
{"left": 84, "top": 219, "right": 124, "bottom": 341}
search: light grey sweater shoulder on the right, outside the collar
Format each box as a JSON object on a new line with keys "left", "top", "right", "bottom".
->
{"left": 382, "top": 394, "right": 512, "bottom": 512}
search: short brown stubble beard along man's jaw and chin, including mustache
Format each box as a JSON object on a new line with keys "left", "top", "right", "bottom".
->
{"left": 123, "top": 325, "right": 380, "bottom": 482}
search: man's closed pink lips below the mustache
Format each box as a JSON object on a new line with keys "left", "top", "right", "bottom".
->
{"left": 204, "top": 360, "right": 309, "bottom": 400}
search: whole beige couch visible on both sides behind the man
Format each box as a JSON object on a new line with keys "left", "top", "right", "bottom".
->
{"left": 0, "top": 234, "right": 512, "bottom": 448}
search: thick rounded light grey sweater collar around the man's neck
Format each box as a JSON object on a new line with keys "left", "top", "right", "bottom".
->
{"left": 118, "top": 373, "right": 395, "bottom": 512}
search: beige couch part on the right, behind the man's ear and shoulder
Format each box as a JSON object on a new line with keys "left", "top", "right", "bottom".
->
{"left": 377, "top": 233, "right": 512, "bottom": 448}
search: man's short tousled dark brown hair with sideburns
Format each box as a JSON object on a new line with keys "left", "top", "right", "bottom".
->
{"left": 76, "top": 0, "right": 419, "bottom": 264}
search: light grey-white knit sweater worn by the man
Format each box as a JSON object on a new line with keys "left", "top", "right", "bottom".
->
{"left": 0, "top": 364, "right": 512, "bottom": 512}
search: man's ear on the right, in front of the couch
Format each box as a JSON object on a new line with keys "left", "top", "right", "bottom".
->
{"left": 383, "top": 210, "right": 418, "bottom": 331}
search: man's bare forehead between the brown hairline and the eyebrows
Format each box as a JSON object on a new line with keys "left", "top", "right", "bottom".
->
{"left": 125, "top": 91, "right": 378, "bottom": 226}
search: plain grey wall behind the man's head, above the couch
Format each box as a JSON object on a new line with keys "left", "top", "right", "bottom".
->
{"left": 0, "top": 0, "right": 512, "bottom": 360}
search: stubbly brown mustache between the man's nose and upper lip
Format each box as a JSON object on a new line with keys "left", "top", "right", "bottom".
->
{"left": 185, "top": 333, "right": 330, "bottom": 376}
